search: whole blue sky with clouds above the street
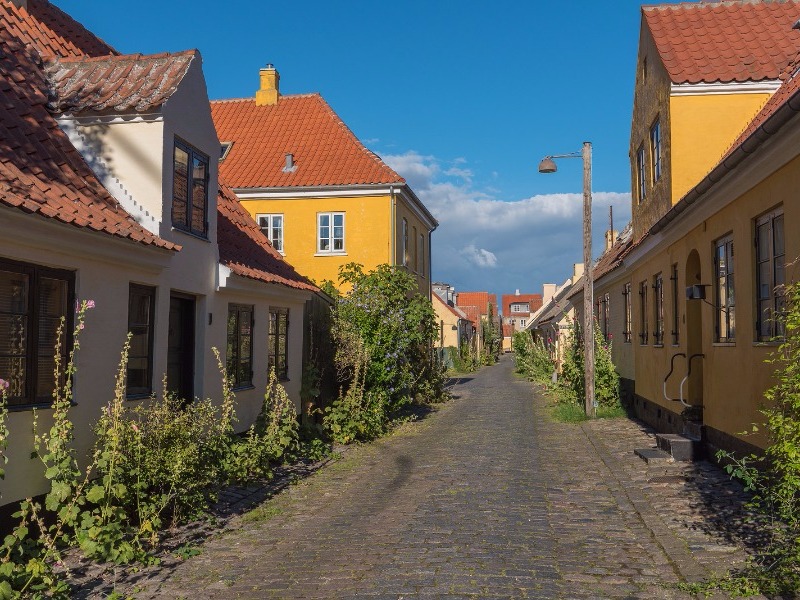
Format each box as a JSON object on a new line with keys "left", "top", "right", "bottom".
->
{"left": 54, "top": 0, "right": 680, "bottom": 294}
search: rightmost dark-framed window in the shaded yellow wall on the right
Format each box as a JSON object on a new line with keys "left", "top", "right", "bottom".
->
{"left": 756, "top": 209, "right": 786, "bottom": 341}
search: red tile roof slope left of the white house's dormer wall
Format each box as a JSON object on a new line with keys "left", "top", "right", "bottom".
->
{"left": 0, "top": 0, "right": 180, "bottom": 249}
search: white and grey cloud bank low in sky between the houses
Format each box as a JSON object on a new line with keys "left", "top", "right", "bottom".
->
{"left": 383, "top": 152, "right": 630, "bottom": 294}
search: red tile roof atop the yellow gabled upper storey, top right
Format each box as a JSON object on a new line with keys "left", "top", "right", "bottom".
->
{"left": 642, "top": 0, "right": 800, "bottom": 83}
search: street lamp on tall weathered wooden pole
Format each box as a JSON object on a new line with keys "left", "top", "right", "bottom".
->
{"left": 539, "top": 142, "right": 595, "bottom": 417}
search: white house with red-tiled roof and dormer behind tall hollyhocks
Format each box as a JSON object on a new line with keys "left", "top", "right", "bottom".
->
{"left": 0, "top": 0, "right": 318, "bottom": 502}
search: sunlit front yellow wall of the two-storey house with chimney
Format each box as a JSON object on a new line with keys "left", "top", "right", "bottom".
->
{"left": 242, "top": 196, "right": 390, "bottom": 284}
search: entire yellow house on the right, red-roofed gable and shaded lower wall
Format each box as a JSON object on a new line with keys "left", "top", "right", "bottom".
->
{"left": 608, "top": 1, "right": 800, "bottom": 458}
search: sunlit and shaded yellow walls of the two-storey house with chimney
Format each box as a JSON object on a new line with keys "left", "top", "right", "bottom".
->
{"left": 241, "top": 194, "right": 430, "bottom": 296}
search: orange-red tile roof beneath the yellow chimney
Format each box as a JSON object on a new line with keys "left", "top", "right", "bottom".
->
{"left": 211, "top": 94, "right": 405, "bottom": 189}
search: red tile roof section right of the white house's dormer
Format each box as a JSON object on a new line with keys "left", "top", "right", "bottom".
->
{"left": 217, "top": 182, "right": 319, "bottom": 292}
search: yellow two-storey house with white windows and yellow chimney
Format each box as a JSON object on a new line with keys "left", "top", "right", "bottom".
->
{"left": 211, "top": 65, "right": 438, "bottom": 297}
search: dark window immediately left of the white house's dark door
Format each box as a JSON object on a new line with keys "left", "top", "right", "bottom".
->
{"left": 126, "top": 283, "right": 156, "bottom": 398}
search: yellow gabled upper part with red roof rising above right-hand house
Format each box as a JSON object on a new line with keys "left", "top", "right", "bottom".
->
{"left": 630, "top": 0, "right": 800, "bottom": 236}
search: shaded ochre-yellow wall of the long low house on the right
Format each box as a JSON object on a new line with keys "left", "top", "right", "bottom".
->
{"left": 628, "top": 157, "right": 800, "bottom": 445}
